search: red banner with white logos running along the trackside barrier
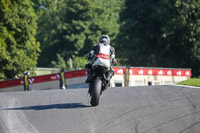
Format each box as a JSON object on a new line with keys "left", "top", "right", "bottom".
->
{"left": 0, "top": 68, "right": 191, "bottom": 88}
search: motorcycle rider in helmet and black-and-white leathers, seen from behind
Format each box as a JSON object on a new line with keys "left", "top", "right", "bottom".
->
{"left": 85, "top": 35, "right": 117, "bottom": 83}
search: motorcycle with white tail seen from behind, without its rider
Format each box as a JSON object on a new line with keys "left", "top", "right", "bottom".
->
{"left": 88, "top": 54, "right": 114, "bottom": 106}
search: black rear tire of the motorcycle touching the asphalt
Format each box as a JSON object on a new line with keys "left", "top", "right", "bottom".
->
{"left": 90, "top": 78, "right": 102, "bottom": 106}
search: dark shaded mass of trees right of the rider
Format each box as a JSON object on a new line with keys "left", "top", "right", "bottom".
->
{"left": 118, "top": 0, "right": 200, "bottom": 76}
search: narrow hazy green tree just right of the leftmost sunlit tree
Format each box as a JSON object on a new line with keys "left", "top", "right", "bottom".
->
{"left": 33, "top": 0, "right": 67, "bottom": 67}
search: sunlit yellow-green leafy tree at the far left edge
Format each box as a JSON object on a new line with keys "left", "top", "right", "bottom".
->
{"left": 0, "top": 0, "right": 40, "bottom": 79}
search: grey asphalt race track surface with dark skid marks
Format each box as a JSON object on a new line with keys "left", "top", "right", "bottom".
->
{"left": 0, "top": 86, "right": 200, "bottom": 133}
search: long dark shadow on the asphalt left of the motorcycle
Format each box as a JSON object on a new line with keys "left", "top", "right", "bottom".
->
{"left": 3, "top": 103, "right": 91, "bottom": 110}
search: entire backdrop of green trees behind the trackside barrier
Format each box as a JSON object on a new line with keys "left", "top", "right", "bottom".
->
{"left": 0, "top": 0, "right": 200, "bottom": 79}
